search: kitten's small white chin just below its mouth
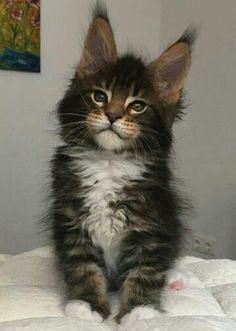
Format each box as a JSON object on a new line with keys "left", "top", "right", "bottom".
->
{"left": 95, "top": 130, "right": 126, "bottom": 150}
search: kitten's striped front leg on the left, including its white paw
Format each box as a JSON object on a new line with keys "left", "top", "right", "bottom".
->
{"left": 56, "top": 223, "right": 110, "bottom": 321}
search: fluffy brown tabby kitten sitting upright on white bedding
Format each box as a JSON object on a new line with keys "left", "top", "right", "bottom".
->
{"left": 50, "top": 2, "right": 194, "bottom": 321}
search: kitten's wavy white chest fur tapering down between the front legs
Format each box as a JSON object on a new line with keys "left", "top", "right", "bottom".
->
{"left": 72, "top": 151, "right": 145, "bottom": 267}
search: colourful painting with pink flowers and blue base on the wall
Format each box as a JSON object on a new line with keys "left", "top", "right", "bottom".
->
{"left": 0, "top": 0, "right": 40, "bottom": 72}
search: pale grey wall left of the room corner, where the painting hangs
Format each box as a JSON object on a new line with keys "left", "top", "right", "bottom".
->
{"left": 0, "top": 0, "right": 160, "bottom": 253}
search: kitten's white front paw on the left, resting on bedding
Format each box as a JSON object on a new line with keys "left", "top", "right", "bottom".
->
{"left": 65, "top": 300, "right": 103, "bottom": 322}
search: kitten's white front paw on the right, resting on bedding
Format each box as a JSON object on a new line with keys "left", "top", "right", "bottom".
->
{"left": 121, "top": 306, "right": 161, "bottom": 324}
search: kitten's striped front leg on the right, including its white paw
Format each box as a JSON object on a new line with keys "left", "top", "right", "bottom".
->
{"left": 116, "top": 232, "right": 173, "bottom": 322}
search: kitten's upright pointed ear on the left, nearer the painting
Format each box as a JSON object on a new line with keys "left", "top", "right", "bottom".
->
{"left": 78, "top": 5, "right": 117, "bottom": 75}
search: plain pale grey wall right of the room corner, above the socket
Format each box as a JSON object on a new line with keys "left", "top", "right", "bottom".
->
{"left": 161, "top": 0, "right": 236, "bottom": 258}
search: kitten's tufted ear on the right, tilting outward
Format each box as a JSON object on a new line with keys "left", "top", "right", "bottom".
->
{"left": 149, "top": 29, "right": 196, "bottom": 105}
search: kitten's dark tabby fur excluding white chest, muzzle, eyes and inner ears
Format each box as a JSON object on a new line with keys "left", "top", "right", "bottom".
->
{"left": 49, "top": 2, "right": 195, "bottom": 321}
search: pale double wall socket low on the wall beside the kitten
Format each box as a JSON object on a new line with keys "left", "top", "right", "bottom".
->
{"left": 192, "top": 234, "right": 216, "bottom": 256}
